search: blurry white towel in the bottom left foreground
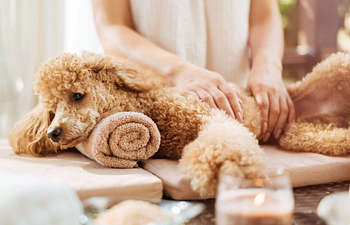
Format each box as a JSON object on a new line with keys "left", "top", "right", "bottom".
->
{"left": 0, "top": 171, "right": 83, "bottom": 225}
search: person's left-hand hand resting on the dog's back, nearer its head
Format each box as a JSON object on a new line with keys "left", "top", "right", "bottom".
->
{"left": 173, "top": 66, "right": 243, "bottom": 122}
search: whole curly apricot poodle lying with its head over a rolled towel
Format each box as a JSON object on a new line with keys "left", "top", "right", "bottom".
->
{"left": 9, "top": 52, "right": 350, "bottom": 197}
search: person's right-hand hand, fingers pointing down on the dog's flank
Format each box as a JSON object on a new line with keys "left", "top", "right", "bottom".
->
{"left": 247, "top": 67, "right": 295, "bottom": 142}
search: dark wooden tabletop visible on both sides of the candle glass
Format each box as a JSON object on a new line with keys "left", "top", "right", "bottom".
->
{"left": 186, "top": 181, "right": 350, "bottom": 225}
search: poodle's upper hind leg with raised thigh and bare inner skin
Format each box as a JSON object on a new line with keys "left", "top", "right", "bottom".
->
{"left": 287, "top": 53, "right": 350, "bottom": 127}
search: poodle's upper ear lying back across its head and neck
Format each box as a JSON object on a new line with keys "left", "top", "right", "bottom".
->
{"left": 82, "top": 52, "right": 163, "bottom": 92}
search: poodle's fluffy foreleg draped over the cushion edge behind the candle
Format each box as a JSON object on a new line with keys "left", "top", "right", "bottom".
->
{"left": 179, "top": 110, "right": 264, "bottom": 197}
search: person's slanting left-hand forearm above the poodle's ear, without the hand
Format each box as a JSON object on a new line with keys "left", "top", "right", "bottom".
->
{"left": 100, "top": 25, "right": 189, "bottom": 84}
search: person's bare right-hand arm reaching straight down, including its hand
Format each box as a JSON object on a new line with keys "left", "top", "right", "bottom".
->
{"left": 247, "top": 0, "right": 295, "bottom": 141}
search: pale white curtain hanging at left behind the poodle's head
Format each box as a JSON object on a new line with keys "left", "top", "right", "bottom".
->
{"left": 0, "top": 0, "right": 64, "bottom": 137}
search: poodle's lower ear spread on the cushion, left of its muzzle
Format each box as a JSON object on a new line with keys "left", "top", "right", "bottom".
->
{"left": 9, "top": 105, "right": 59, "bottom": 156}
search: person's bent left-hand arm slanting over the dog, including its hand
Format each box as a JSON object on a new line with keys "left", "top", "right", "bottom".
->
{"left": 92, "top": 0, "right": 243, "bottom": 120}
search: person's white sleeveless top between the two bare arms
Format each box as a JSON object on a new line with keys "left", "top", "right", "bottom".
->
{"left": 130, "top": 0, "right": 250, "bottom": 87}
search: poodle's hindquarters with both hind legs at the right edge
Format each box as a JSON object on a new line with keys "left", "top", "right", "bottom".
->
{"left": 279, "top": 53, "right": 350, "bottom": 155}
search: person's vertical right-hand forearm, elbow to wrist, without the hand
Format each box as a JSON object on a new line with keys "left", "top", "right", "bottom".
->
{"left": 249, "top": 9, "right": 284, "bottom": 75}
